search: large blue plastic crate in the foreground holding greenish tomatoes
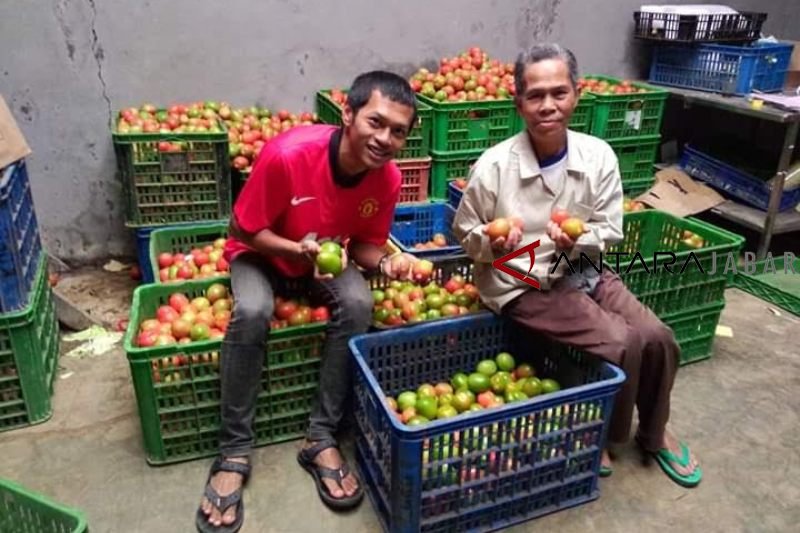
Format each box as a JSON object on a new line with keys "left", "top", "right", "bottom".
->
{"left": 349, "top": 314, "right": 625, "bottom": 532}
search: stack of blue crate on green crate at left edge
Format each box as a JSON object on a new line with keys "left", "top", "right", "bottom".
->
{"left": 0, "top": 160, "right": 59, "bottom": 431}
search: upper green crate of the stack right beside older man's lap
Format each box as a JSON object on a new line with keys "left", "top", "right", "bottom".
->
{"left": 608, "top": 209, "right": 745, "bottom": 317}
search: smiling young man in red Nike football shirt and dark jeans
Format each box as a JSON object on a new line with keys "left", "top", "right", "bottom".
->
{"left": 196, "top": 71, "right": 416, "bottom": 532}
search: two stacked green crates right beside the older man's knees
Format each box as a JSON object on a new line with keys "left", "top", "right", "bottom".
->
{"left": 608, "top": 210, "right": 744, "bottom": 364}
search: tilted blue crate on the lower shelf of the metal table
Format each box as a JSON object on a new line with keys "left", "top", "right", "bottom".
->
{"left": 681, "top": 145, "right": 800, "bottom": 211}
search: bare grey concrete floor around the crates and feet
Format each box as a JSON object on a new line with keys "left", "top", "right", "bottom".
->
{"left": 0, "top": 289, "right": 800, "bottom": 533}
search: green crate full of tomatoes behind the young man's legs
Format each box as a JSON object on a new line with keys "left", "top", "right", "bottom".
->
{"left": 124, "top": 278, "right": 329, "bottom": 464}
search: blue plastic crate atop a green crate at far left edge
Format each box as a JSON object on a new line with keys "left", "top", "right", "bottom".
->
{"left": 0, "top": 160, "right": 42, "bottom": 313}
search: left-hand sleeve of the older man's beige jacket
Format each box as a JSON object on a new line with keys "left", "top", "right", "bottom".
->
{"left": 453, "top": 158, "right": 498, "bottom": 263}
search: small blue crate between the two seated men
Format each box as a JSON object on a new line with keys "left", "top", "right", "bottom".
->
{"left": 389, "top": 202, "right": 464, "bottom": 257}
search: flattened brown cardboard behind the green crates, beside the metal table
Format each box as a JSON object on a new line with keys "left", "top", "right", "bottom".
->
{"left": 636, "top": 167, "right": 725, "bottom": 217}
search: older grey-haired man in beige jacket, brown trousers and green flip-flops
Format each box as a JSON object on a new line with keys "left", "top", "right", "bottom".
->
{"left": 453, "top": 44, "right": 702, "bottom": 487}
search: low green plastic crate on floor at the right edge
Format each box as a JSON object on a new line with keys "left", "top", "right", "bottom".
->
{"left": 734, "top": 256, "right": 800, "bottom": 316}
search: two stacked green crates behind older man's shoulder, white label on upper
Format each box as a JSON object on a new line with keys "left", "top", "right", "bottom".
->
{"left": 585, "top": 75, "right": 668, "bottom": 197}
